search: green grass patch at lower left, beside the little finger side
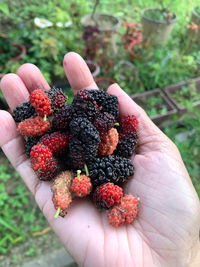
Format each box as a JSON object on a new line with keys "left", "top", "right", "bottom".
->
{"left": 0, "top": 152, "right": 47, "bottom": 254}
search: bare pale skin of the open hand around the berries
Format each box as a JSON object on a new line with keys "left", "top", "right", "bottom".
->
{"left": 0, "top": 53, "right": 200, "bottom": 267}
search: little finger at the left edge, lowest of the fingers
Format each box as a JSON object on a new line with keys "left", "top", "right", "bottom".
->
{"left": 0, "top": 110, "right": 38, "bottom": 196}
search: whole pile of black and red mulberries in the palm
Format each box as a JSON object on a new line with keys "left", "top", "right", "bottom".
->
{"left": 13, "top": 88, "right": 139, "bottom": 227}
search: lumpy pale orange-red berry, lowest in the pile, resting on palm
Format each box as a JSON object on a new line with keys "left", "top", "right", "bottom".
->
{"left": 108, "top": 195, "right": 139, "bottom": 227}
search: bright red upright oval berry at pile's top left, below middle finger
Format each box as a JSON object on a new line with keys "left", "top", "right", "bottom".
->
{"left": 30, "top": 89, "right": 51, "bottom": 117}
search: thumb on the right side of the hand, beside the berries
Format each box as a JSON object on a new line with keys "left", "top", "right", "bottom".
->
{"left": 108, "top": 84, "right": 168, "bottom": 152}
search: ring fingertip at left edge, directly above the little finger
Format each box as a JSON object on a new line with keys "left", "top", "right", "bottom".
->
{"left": 1, "top": 73, "right": 29, "bottom": 110}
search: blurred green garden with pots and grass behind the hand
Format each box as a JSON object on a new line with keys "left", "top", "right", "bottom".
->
{"left": 0, "top": 0, "right": 200, "bottom": 266}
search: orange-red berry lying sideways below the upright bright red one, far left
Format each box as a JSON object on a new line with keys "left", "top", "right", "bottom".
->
{"left": 17, "top": 116, "right": 51, "bottom": 137}
